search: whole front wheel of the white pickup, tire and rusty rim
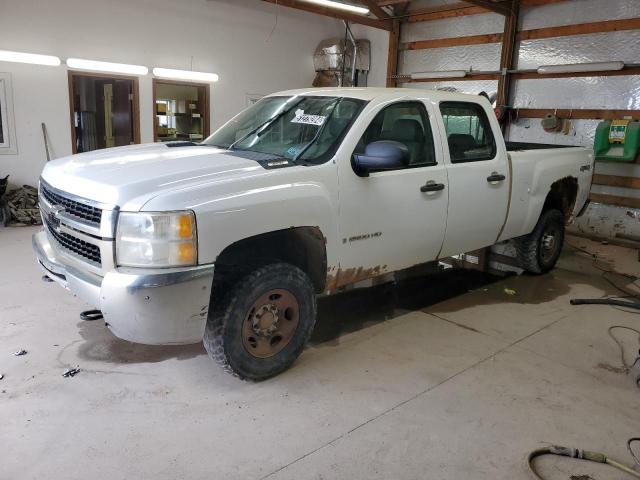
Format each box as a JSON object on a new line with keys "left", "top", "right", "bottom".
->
{"left": 203, "top": 263, "right": 316, "bottom": 380}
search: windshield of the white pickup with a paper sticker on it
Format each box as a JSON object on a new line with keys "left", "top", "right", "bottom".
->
{"left": 203, "top": 96, "right": 365, "bottom": 163}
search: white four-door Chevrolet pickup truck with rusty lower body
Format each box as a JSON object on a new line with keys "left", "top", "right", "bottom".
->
{"left": 33, "top": 88, "right": 593, "bottom": 380}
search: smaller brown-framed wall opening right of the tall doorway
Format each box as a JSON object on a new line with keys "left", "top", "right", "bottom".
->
{"left": 153, "top": 78, "right": 209, "bottom": 142}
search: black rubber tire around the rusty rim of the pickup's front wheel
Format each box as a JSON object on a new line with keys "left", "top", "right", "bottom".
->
{"left": 203, "top": 263, "right": 316, "bottom": 380}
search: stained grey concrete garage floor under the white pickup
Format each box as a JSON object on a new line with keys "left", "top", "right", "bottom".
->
{"left": 0, "top": 228, "right": 640, "bottom": 480}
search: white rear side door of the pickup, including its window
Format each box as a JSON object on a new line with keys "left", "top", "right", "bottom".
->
{"left": 440, "top": 102, "right": 511, "bottom": 256}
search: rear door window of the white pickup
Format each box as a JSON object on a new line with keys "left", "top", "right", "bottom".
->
{"left": 440, "top": 102, "right": 496, "bottom": 163}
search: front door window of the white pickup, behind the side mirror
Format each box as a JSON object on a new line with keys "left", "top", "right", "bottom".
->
{"left": 354, "top": 102, "right": 436, "bottom": 168}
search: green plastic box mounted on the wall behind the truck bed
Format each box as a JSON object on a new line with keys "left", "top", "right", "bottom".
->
{"left": 593, "top": 120, "right": 640, "bottom": 162}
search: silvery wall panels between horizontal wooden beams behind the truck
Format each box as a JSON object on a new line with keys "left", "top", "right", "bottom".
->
{"left": 398, "top": 0, "right": 640, "bottom": 244}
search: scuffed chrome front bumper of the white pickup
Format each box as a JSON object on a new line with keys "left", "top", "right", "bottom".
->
{"left": 32, "top": 231, "right": 214, "bottom": 345}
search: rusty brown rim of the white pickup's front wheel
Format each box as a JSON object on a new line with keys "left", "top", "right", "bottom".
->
{"left": 242, "top": 288, "right": 300, "bottom": 358}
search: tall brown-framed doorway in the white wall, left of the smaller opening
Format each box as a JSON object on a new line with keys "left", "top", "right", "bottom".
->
{"left": 69, "top": 72, "right": 140, "bottom": 153}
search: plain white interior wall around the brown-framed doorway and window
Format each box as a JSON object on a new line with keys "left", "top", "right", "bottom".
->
{"left": 0, "top": 0, "right": 388, "bottom": 184}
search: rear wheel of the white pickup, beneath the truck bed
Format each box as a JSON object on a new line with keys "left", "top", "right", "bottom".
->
{"left": 514, "top": 210, "right": 564, "bottom": 274}
